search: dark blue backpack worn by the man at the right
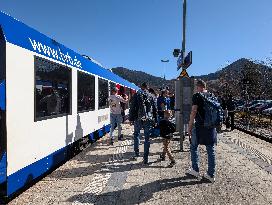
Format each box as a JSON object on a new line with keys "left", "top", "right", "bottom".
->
{"left": 199, "top": 93, "right": 224, "bottom": 128}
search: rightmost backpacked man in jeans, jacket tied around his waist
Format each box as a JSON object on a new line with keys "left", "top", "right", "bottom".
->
{"left": 187, "top": 80, "right": 223, "bottom": 182}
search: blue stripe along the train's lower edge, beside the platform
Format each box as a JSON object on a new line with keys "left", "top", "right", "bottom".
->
{"left": 7, "top": 125, "right": 109, "bottom": 196}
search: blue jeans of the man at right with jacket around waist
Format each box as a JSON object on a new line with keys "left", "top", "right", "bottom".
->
{"left": 190, "top": 127, "right": 216, "bottom": 177}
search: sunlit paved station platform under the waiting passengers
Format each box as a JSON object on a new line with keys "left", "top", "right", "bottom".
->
{"left": 9, "top": 124, "right": 272, "bottom": 205}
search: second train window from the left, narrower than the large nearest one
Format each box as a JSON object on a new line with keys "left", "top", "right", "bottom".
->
{"left": 77, "top": 71, "right": 95, "bottom": 112}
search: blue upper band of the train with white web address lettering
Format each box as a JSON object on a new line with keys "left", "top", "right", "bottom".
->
{"left": 0, "top": 11, "right": 139, "bottom": 90}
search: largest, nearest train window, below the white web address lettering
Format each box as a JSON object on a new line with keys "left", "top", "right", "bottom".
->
{"left": 35, "top": 57, "right": 72, "bottom": 120}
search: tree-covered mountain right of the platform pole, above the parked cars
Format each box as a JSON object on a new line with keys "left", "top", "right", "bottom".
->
{"left": 196, "top": 58, "right": 272, "bottom": 99}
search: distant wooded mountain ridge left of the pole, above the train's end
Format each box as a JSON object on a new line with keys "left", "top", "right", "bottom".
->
{"left": 111, "top": 67, "right": 174, "bottom": 90}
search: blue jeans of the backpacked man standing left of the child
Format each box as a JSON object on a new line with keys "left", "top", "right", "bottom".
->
{"left": 134, "top": 120, "right": 153, "bottom": 163}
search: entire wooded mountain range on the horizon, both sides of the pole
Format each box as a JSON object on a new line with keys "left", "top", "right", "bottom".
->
{"left": 111, "top": 58, "right": 272, "bottom": 99}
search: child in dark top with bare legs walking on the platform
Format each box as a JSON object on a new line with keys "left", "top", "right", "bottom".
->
{"left": 159, "top": 110, "right": 176, "bottom": 167}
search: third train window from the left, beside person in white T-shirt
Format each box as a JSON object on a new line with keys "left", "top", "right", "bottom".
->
{"left": 98, "top": 78, "right": 109, "bottom": 109}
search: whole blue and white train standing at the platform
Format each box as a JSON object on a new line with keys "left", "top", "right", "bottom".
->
{"left": 0, "top": 12, "right": 138, "bottom": 197}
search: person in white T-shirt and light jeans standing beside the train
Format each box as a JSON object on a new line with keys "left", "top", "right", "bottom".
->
{"left": 108, "top": 88, "right": 128, "bottom": 145}
